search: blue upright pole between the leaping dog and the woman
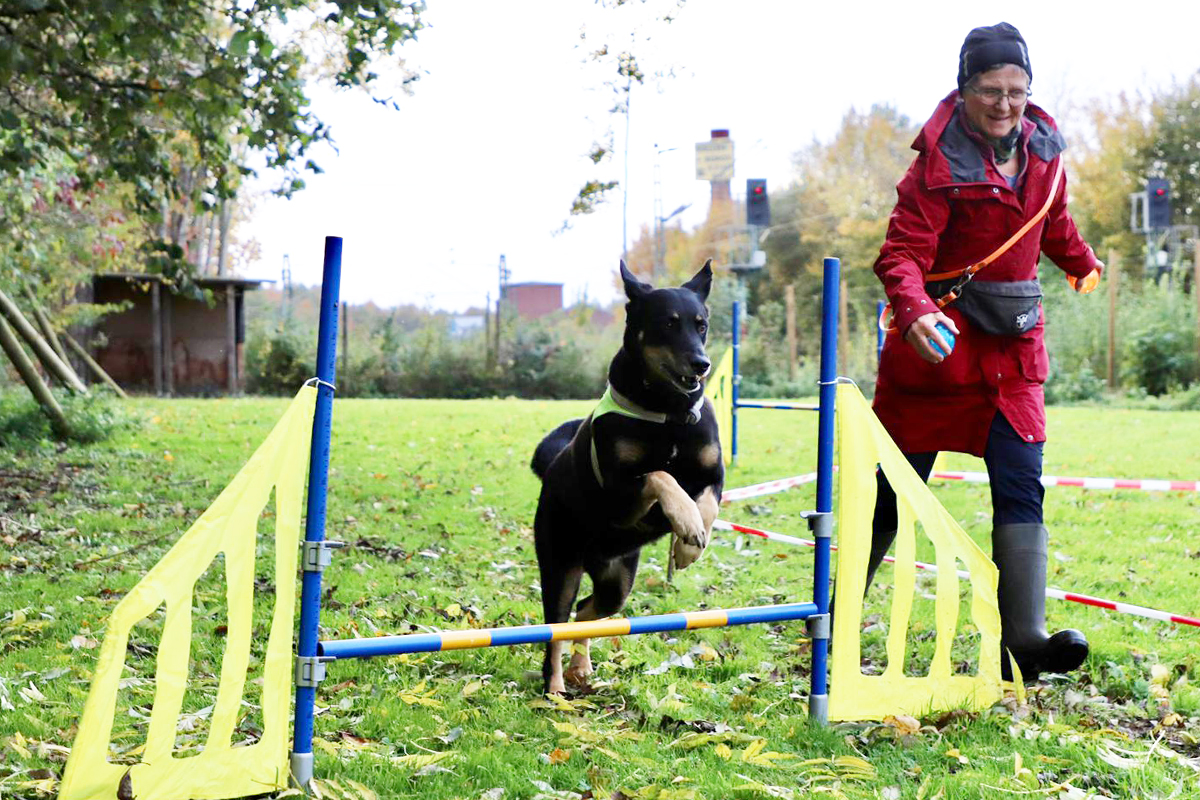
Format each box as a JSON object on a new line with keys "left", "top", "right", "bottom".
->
{"left": 809, "top": 258, "right": 841, "bottom": 723}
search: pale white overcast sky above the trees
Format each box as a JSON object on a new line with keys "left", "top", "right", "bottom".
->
{"left": 240, "top": 0, "right": 1200, "bottom": 309}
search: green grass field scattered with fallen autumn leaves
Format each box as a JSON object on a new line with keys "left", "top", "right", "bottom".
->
{"left": 0, "top": 399, "right": 1200, "bottom": 800}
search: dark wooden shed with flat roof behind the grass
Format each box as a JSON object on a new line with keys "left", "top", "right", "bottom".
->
{"left": 91, "top": 273, "right": 271, "bottom": 397}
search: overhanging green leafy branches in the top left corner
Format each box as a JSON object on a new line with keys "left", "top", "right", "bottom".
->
{"left": 0, "top": 0, "right": 424, "bottom": 211}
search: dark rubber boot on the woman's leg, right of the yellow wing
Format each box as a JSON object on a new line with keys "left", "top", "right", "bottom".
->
{"left": 991, "top": 523, "right": 1087, "bottom": 682}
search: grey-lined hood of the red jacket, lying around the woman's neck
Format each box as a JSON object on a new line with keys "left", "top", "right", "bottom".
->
{"left": 912, "top": 90, "right": 1067, "bottom": 187}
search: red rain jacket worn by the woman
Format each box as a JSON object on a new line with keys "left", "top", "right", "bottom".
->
{"left": 874, "top": 91, "right": 1099, "bottom": 456}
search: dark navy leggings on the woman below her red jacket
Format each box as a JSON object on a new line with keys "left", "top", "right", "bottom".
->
{"left": 871, "top": 411, "right": 1045, "bottom": 533}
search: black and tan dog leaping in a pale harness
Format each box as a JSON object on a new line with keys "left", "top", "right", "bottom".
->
{"left": 532, "top": 260, "right": 725, "bottom": 692}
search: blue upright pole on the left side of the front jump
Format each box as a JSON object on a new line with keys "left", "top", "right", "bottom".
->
{"left": 290, "top": 236, "right": 342, "bottom": 788}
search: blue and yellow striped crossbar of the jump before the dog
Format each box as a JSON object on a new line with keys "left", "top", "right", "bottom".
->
{"left": 318, "top": 603, "right": 817, "bottom": 658}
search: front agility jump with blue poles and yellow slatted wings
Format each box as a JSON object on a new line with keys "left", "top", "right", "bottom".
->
{"left": 59, "top": 237, "right": 1003, "bottom": 800}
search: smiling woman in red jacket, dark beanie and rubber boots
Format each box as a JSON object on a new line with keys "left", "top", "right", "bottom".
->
{"left": 868, "top": 23, "right": 1102, "bottom": 679}
